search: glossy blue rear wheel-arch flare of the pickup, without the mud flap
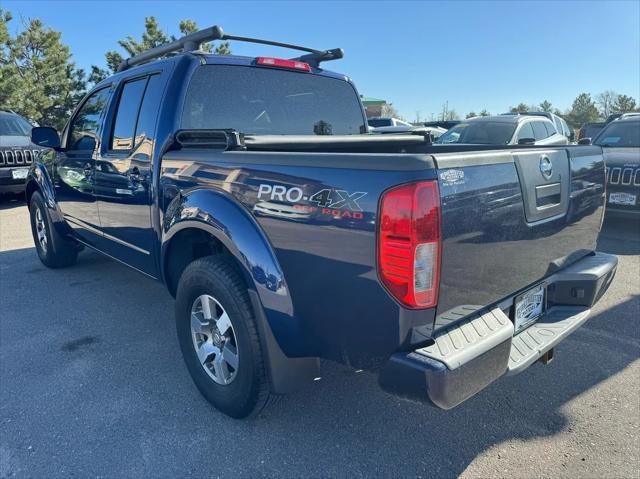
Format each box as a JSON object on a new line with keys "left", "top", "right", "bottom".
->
{"left": 161, "top": 189, "right": 310, "bottom": 357}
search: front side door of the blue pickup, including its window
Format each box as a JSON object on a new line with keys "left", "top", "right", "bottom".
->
{"left": 54, "top": 87, "right": 111, "bottom": 246}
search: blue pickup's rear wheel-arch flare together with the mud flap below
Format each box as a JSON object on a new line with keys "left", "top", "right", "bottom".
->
{"left": 161, "top": 189, "right": 318, "bottom": 392}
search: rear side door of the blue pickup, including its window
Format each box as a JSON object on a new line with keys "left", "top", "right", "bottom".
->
{"left": 95, "top": 74, "right": 164, "bottom": 276}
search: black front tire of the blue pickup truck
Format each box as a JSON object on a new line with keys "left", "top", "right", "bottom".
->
{"left": 29, "top": 191, "right": 78, "bottom": 268}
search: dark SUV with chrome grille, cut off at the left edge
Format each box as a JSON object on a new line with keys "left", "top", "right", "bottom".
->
{"left": 0, "top": 110, "right": 41, "bottom": 194}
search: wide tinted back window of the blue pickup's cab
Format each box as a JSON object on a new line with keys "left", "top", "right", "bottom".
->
{"left": 181, "top": 65, "right": 367, "bottom": 135}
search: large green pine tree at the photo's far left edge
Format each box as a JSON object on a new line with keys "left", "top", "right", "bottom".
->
{"left": 0, "top": 10, "right": 86, "bottom": 130}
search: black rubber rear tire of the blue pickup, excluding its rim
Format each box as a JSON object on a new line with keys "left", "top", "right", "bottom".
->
{"left": 176, "top": 256, "right": 269, "bottom": 419}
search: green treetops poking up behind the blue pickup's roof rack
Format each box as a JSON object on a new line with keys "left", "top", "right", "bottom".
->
{"left": 95, "top": 16, "right": 231, "bottom": 83}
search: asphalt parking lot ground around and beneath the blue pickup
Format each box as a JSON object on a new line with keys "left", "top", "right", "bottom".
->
{"left": 0, "top": 196, "right": 640, "bottom": 478}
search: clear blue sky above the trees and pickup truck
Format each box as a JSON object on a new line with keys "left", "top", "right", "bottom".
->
{"left": 0, "top": 0, "right": 640, "bottom": 119}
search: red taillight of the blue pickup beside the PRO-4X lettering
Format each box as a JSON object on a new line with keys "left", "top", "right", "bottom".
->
{"left": 378, "top": 181, "right": 441, "bottom": 308}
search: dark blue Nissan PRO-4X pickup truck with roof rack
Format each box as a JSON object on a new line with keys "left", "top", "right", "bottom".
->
{"left": 26, "top": 27, "right": 617, "bottom": 418}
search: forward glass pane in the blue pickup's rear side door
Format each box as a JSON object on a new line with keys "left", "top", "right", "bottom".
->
{"left": 109, "top": 77, "right": 147, "bottom": 151}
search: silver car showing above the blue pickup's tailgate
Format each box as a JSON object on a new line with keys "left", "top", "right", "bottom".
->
{"left": 436, "top": 115, "right": 569, "bottom": 145}
